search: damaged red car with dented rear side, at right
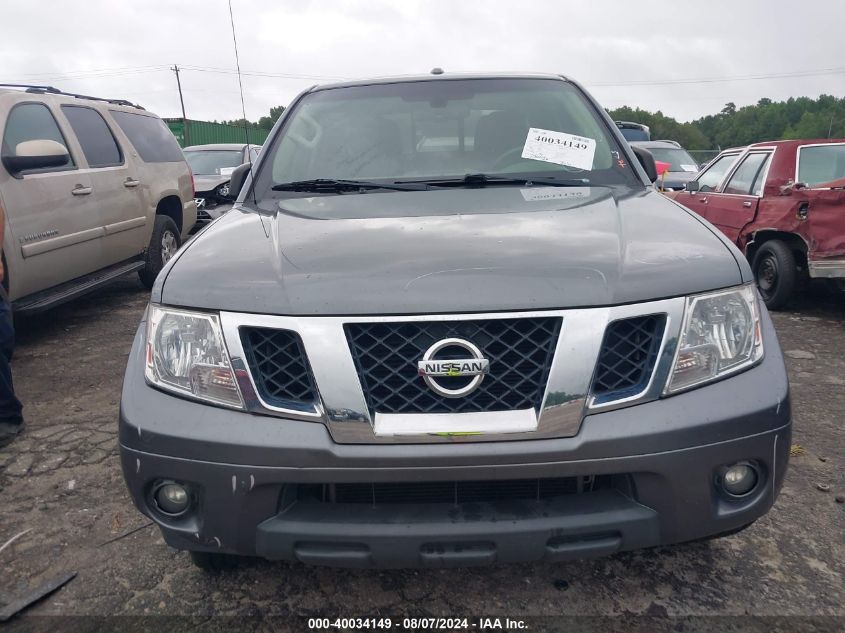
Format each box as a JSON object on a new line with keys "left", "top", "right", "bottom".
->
{"left": 667, "top": 139, "right": 845, "bottom": 309}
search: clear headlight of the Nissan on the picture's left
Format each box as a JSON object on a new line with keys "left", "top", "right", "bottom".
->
{"left": 145, "top": 305, "right": 243, "bottom": 409}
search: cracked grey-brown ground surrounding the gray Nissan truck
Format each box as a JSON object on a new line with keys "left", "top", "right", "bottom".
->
{"left": 0, "top": 277, "right": 845, "bottom": 630}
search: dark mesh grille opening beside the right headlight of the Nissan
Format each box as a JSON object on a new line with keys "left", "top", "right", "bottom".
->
{"left": 593, "top": 314, "right": 666, "bottom": 402}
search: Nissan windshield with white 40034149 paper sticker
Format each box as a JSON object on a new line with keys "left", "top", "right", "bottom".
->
{"left": 256, "top": 79, "right": 642, "bottom": 197}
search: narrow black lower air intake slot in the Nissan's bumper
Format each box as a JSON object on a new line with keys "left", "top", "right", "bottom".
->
{"left": 297, "top": 475, "right": 612, "bottom": 505}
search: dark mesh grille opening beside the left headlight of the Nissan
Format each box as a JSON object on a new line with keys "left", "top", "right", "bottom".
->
{"left": 241, "top": 327, "right": 317, "bottom": 408}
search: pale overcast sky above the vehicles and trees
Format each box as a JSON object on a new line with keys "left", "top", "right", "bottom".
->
{"left": 0, "top": 0, "right": 845, "bottom": 120}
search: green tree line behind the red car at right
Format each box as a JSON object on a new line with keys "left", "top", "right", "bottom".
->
{"left": 608, "top": 95, "right": 845, "bottom": 150}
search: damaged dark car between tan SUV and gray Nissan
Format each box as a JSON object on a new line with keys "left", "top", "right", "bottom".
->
{"left": 183, "top": 143, "right": 261, "bottom": 231}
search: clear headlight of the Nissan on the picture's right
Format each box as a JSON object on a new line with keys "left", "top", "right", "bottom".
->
{"left": 666, "top": 284, "right": 763, "bottom": 393}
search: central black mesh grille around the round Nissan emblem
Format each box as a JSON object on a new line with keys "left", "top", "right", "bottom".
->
{"left": 345, "top": 317, "right": 560, "bottom": 413}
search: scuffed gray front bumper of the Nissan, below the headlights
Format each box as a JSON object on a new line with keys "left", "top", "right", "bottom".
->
{"left": 120, "top": 317, "right": 791, "bottom": 567}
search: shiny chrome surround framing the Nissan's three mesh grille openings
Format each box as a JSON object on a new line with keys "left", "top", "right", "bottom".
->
{"left": 220, "top": 297, "right": 685, "bottom": 444}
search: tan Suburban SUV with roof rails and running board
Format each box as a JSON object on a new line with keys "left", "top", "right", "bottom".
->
{"left": 0, "top": 86, "right": 196, "bottom": 312}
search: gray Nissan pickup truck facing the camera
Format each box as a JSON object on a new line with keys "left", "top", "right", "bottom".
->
{"left": 120, "top": 73, "right": 791, "bottom": 570}
